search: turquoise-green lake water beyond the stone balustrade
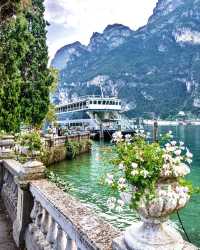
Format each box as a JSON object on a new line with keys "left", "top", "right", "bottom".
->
{"left": 51, "top": 126, "right": 200, "bottom": 247}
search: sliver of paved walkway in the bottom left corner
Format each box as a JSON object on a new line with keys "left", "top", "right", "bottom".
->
{"left": 0, "top": 198, "right": 17, "bottom": 250}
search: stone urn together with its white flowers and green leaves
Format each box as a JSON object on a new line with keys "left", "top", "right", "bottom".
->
{"left": 106, "top": 130, "right": 195, "bottom": 250}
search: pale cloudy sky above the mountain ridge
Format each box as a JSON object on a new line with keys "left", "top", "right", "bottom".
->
{"left": 45, "top": 0, "right": 158, "bottom": 59}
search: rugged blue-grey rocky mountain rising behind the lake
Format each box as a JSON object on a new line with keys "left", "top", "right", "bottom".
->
{"left": 52, "top": 0, "right": 200, "bottom": 118}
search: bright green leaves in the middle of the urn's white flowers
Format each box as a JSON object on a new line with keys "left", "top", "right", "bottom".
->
{"left": 113, "top": 137, "right": 163, "bottom": 206}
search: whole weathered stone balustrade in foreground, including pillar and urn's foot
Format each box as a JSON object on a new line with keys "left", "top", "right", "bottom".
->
{"left": 0, "top": 160, "right": 198, "bottom": 250}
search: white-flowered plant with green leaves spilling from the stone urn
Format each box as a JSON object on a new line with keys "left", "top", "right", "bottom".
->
{"left": 106, "top": 130, "right": 193, "bottom": 210}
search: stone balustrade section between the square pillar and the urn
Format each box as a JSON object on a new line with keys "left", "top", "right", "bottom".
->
{"left": 26, "top": 180, "right": 119, "bottom": 250}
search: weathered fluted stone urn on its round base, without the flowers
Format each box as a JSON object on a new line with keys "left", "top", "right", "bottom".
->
{"left": 124, "top": 176, "right": 190, "bottom": 250}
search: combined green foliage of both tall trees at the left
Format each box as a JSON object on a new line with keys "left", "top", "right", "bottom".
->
{"left": 0, "top": 0, "right": 53, "bottom": 132}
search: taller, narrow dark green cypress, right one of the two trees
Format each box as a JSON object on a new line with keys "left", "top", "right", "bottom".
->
{"left": 21, "top": 0, "right": 54, "bottom": 127}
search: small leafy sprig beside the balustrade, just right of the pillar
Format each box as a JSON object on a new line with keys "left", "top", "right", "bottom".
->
{"left": 46, "top": 170, "right": 71, "bottom": 192}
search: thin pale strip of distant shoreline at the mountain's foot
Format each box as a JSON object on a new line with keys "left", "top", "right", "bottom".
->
{"left": 143, "top": 120, "right": 200, "bottom": 126}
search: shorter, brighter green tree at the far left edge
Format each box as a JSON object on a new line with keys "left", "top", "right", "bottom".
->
{"left": 0, "top": 15, "right": 32, "bottom": 132}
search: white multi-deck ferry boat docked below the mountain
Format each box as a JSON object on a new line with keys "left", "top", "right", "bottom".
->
{"left": 56, "top": 96, "right": 122, "bottom": 131}
